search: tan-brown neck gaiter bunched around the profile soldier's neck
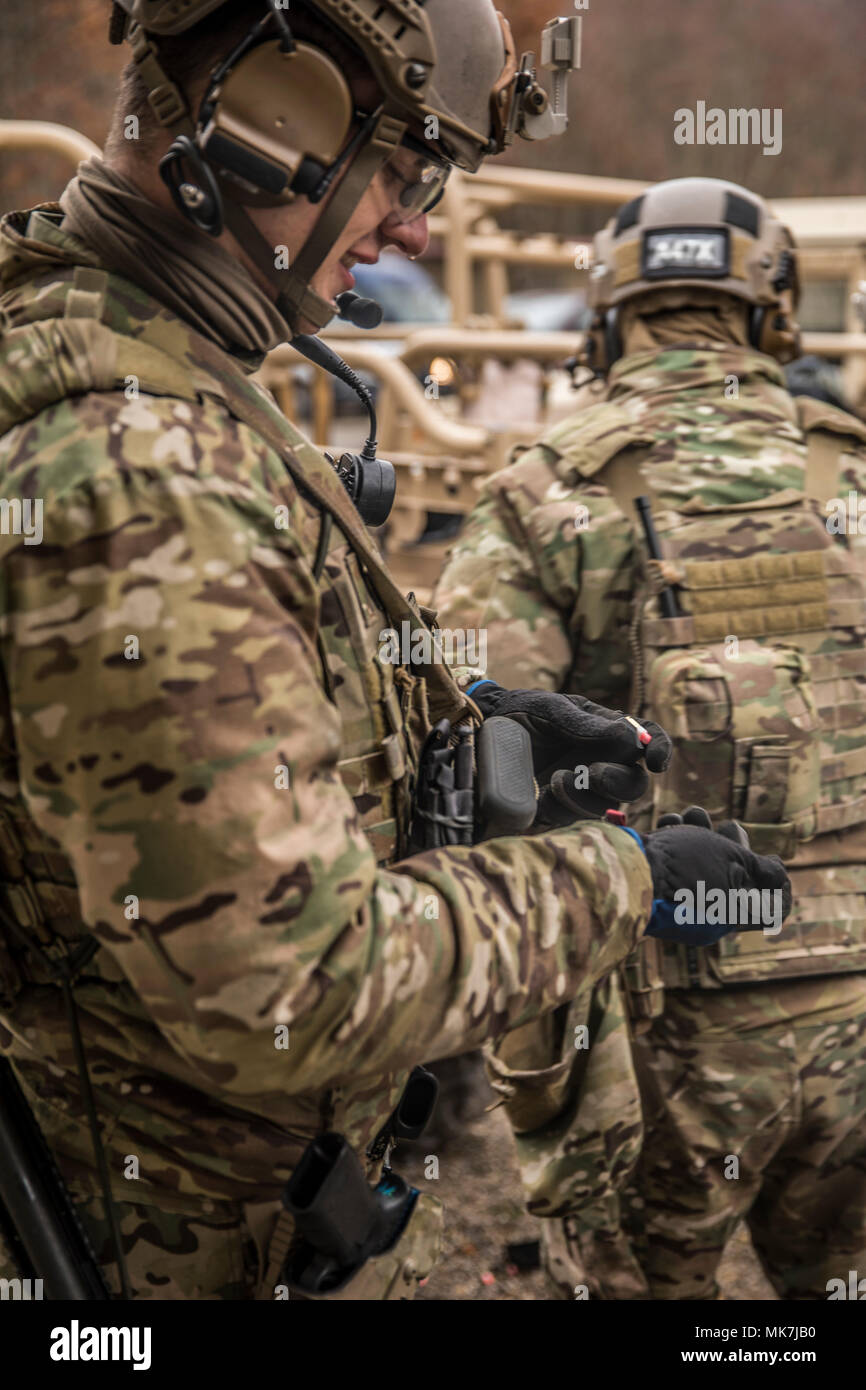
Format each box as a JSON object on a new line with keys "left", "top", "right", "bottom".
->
{"left": 60, "top": 158, "right": 292, "bottom": 356}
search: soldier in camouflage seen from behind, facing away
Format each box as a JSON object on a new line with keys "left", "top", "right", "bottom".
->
{"left": 434, "top": 179, "right": 866, "bottom": 1298}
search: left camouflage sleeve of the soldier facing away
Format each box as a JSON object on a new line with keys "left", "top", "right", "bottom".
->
{"left": 432, "top": 445, "right": 632, "bottom": 705}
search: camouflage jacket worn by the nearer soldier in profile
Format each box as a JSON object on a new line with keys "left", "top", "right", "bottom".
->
{"left": 0, "top": 206, "right": 651, "bottom": 1211}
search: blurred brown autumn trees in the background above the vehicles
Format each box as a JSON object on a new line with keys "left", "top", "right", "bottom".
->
{"left": 0, "top": 0, "right": 866, "bottom": 214}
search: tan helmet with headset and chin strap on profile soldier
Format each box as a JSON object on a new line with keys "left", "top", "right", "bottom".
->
{"left": 110, "top": 0, "right": 580, "bottom": 332}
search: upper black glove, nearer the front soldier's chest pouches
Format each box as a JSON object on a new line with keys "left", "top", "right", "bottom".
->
{"left": 470, "top": 681, "right": 673, "bottom": 830}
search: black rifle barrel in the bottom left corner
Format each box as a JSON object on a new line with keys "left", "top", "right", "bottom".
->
{"left": 0, "top": 1058, "right": 111, "bottom": 1301}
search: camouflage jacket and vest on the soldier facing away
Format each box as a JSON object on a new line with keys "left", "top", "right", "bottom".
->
{"left": 432, "top": 346, "right": 866, "bottom": 995}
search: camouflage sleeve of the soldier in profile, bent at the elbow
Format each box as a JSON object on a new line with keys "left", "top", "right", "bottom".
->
{"left": 3, "top": 396, "right": 651, "bottom": 1097}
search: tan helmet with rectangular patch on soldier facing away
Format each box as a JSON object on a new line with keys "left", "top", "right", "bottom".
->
{"left": 582, "top": 178, "right": 799, "bottom": 375}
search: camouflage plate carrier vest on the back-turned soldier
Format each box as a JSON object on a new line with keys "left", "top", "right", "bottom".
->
{"left": 603, "top": 402, "right": 866, "bottom": 995}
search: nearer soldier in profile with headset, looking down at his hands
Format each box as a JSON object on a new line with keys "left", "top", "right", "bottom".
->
{"left": 0, "top": 0, "right": 795, "bottom": 1298}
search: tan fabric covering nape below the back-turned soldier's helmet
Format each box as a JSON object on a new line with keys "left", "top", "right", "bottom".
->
{"left": 620, "top": 288, "right": 749, "bottom": 356}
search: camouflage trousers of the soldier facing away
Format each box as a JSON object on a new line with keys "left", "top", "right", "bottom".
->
{"left": 542, "top": 976, "right": 866, "bottom": 1300}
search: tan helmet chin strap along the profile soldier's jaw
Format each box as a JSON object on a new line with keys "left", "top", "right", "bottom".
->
{"left": 218, "top": 115, "right": 406, "bottom": 336}
